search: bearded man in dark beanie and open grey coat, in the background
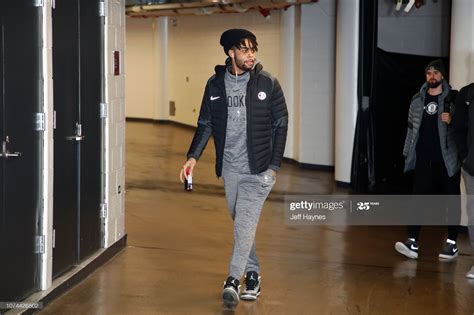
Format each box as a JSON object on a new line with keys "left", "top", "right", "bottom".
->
{"left": 395, "top": 59, "right": 461, "bottom": 260}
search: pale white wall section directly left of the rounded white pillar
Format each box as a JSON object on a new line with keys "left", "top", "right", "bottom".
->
{"left": 298, "top": 0, "right": 336, "bottom": 166}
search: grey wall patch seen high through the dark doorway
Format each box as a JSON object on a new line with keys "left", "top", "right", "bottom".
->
{"left": 378, "top": 0, "right": 452, "bottom": 57}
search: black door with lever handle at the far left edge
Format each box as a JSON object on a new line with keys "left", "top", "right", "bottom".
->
{"left": 0, "top": 0, "right": 42, "bottom": 301}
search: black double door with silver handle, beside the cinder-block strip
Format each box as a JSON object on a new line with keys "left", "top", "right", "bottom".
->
{"left": 53, "top": 0, "right": 102, "bottom": 277}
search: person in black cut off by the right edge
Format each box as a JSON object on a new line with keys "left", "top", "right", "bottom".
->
{"left": 453, "top": 83, "right": 474, "bottom": 279}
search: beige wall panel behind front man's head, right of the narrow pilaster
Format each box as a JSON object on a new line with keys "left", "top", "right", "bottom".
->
{"left": 168, "top": 11, "right": 280, "bottom": 126}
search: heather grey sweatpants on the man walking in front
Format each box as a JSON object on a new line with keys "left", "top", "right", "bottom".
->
{"left": 222, "top": 170, "right": 275, "bottom": 279}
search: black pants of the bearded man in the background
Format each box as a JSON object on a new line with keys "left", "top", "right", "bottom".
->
{"left": 408, "top": 156, "right": 461, "bottom": 241}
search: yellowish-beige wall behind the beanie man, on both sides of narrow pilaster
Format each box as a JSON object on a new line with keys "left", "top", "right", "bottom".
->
{"left": 126, "top": 11, "right": 280, "bottom": 126}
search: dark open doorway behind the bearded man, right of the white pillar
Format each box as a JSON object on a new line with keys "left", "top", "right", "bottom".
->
{"left": 351, "top": 0, "right": 451, "bottom": 194}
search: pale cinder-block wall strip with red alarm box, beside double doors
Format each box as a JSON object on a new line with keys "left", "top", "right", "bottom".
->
{"left": 104, "top": 0, "right": 125, "bottom": 247}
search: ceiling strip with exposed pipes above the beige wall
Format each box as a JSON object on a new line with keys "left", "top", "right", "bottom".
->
{"left": 126, "top": 0, "right": 318, "bottom": 18}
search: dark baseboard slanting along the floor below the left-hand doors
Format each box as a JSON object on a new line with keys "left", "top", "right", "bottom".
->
{"left": 5, "top": 234, "right": 127, "bottom": 314}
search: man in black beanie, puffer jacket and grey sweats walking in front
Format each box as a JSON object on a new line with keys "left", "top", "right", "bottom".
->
{"left": 180, "top": 29, "right": 288, "bottom": 308}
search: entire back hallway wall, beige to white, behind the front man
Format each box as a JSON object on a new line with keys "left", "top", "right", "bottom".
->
{"left": 122, "top": 0, "right": 336, "bottom": 166}
